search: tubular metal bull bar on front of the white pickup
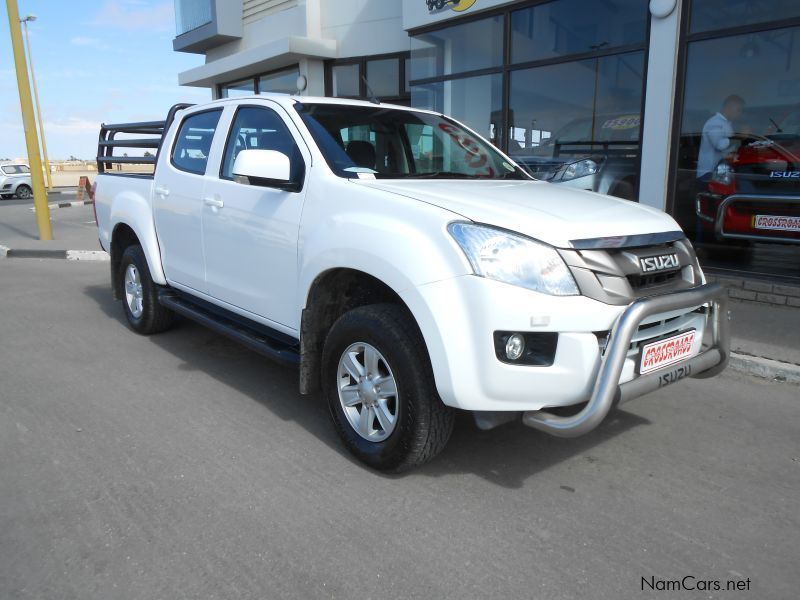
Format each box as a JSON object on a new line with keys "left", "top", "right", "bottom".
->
{"left": 522, "top": 283, "right": 730, "bottom": 438}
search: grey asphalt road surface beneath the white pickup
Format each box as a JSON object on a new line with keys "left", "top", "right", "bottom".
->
{"left": 0, "top": 259, "right": 800, "bottom": 600}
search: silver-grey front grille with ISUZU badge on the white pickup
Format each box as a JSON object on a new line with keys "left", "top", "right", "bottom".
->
{"left": 559, "top": 238, "right": 702, "bottom": 305}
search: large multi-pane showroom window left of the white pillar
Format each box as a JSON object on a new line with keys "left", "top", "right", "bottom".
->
{"left": 411, "top": 0, "right": 648, "bottom": 199}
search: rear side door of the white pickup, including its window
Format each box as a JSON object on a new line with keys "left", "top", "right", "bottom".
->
{"left": 153, "top": 108, "right": 222, "bottom": 292}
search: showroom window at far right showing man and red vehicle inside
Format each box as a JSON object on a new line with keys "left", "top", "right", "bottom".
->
{"left": 673, "top": 22, "right": 800, "bottom": 278}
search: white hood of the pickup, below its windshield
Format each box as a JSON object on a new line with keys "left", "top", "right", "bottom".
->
{"left": 353, "top": 179, "right": 680, "bottom": 248}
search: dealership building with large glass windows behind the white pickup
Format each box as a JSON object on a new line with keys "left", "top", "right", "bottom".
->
{"left": 173, "top": 0, "right": 800, "bottom": 286}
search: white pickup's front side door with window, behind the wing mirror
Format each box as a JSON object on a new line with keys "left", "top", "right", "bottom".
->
{"left": 203, "top": 101, "right": 311, "bottom": 329}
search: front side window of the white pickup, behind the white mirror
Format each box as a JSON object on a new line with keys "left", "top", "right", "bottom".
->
{"left": 220, "top": 106, "right": 305, "bottom": 181}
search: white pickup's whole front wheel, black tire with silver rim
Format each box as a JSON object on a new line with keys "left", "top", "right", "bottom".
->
{"left": 322, "top": 304, "right": 455, "bottom": 472}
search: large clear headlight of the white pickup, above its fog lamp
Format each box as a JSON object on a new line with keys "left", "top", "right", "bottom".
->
{"left": 447, "top": 223, "right": 580, "bottom": 296}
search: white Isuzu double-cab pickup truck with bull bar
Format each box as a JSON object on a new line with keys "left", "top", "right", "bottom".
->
{"left": 95, "top": 95, "right": 729, "bottom": 471}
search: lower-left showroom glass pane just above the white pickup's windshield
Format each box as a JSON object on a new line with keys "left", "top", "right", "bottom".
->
{"left": 411, "top": 74, "right": 503, "bottom": 146}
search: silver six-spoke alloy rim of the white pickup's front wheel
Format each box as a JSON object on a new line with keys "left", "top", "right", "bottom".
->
{"left": 336, "top": 342, "right": 400, "bottom": 442}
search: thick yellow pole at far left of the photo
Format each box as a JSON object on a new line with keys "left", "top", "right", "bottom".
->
{"left": 6, "top": 0, "right": 53, "bottom": 240}
